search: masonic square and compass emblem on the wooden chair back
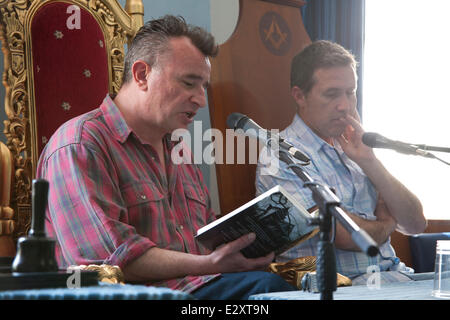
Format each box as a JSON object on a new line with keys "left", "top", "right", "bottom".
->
{"left": 259, "top": 11, "right": 291, "bottom": 56}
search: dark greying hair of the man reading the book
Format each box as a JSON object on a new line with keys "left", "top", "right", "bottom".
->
{"left": 122, "top": 15, "right": 218, "bottom": 84}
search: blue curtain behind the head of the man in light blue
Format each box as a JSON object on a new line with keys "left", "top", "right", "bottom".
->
{"left": 301, "top": 0, "right": 365, "bottom": 115}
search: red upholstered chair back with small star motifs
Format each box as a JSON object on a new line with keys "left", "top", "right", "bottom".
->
{"left": 31, "top": 2, "right": 109, "bottom": 154}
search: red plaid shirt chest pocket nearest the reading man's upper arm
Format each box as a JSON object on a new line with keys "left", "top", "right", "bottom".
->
{"left": 122, "top": 182, "right": 166, "bottom": 235}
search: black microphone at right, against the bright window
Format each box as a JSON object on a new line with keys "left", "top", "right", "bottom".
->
{"left": 362, "top": 132, "right": 433, "bottom": 158}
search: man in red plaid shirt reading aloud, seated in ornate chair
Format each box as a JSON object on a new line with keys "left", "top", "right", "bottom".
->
{"left": 37, "top": 16, "right": 294, "bottom": 299}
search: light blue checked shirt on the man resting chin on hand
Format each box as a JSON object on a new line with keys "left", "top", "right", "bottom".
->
{"left": 256, "top": 115, "right": 413, "bottom": 278}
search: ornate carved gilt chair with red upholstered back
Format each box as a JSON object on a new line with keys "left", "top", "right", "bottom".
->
{"left": 0, "top": 0, "right": 144, "bottom": 249}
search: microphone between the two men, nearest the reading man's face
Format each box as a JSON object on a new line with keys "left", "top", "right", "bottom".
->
{"left": 227, "top": 112, "right": 311, "bottom": 163}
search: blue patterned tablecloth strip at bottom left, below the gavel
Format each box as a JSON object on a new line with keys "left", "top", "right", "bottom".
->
{"left": 0, "top": 284, "right": 194, "bottom": 300}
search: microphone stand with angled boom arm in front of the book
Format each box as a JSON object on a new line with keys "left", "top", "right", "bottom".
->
{"left": 279, "top": 150, "right": 379, "bottom": 300}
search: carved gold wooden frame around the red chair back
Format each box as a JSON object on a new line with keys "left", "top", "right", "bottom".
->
{"left": 0, "top": 0, "right": 144, "bottom": 238}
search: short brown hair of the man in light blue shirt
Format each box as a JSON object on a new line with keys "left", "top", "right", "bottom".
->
{"left": 291, "top": 40, "right": 357, "bottom": 94}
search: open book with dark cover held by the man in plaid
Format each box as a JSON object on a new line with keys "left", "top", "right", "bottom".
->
{"left": 195, "top": 185, "right": 318, "bottom": 258}
